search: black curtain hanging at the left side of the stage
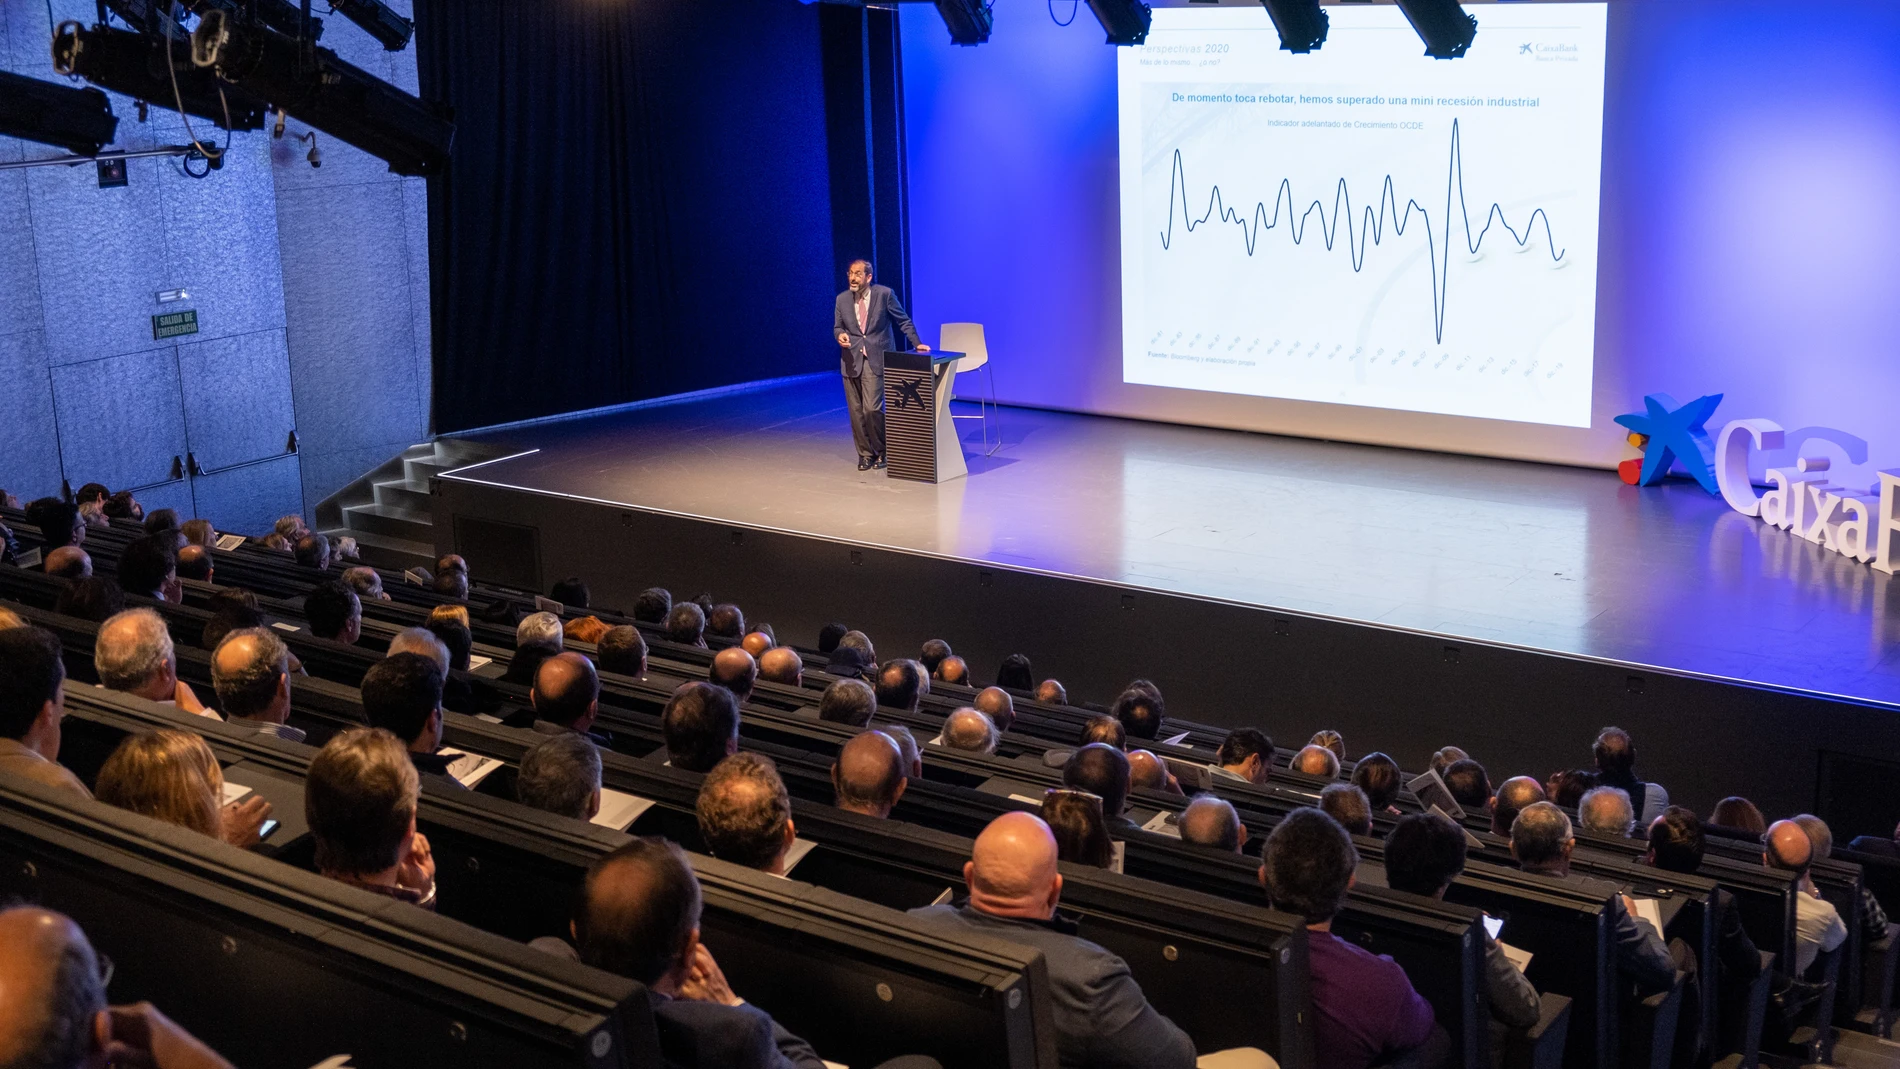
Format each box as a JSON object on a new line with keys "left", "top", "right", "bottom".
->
{"left": 414, "top": 0, "right": 842, "bottom": 431}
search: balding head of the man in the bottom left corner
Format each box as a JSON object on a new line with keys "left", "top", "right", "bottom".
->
{"left": 0, "top": 908, "right": 106, "bottom": 1069}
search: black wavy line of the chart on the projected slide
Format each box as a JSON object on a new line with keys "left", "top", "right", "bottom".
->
{"left": 1161, "top": 118, "right": 1566, "bottom": 344}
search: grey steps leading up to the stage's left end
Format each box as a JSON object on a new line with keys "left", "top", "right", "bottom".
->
{"left": 315, "top": 439, "right": 504, "bottom": 572}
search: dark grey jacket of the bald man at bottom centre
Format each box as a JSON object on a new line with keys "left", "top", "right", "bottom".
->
{"left": 910, "top": 906, "right": 1195, "bottom": 1069}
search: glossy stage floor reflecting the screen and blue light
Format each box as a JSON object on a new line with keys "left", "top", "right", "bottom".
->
{"left": 444, "top": 376, "right": 1900, "bottom": 703}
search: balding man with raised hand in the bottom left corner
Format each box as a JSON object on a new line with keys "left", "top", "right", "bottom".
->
{"left": 0, "top": 906, "right": 230, "bottom": 1069}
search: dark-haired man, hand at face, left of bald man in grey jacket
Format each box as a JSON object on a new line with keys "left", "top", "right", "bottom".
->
{"left": 551, "top": 835, "right": 825, "bottom": 1069}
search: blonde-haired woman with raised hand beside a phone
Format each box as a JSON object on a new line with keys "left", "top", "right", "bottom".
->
{"left": 95, "top": 727, "right": 270, "bottom": 847}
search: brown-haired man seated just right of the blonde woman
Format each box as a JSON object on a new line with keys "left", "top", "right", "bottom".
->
{"left": 304, "top": 727, "right": 435, "bottom": 910}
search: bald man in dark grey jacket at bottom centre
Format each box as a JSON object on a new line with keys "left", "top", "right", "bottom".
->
{"left": 910, "top": 816, "right": 1195, "bottom": 1069}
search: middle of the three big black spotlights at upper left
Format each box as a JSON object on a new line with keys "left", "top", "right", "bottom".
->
{"left": 53, "top": 23, "right": 268, "bottom": 131}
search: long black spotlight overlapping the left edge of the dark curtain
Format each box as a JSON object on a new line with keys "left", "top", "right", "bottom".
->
{"left": 192, "top": 11, "right": 454, "bottom": 175}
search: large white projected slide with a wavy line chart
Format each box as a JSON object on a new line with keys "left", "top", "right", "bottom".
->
{"left": 1119, "top": 4, "right": 1606, "bottom": 427}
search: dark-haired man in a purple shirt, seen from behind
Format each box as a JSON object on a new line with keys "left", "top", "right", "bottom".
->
{"left": 1260, "top": 809, "right": 1452, "bottom": 1069}
